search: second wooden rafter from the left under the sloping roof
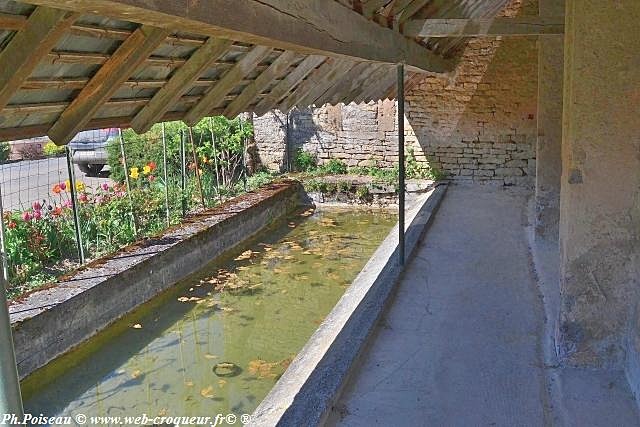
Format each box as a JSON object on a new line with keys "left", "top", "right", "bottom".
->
{"left": 48, "top": 26, "right": 168, "bottom": 145}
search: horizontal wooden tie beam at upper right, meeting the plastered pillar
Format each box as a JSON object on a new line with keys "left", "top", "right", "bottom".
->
{"left": 402, "top": 16, "right": 564, "bottom": 37}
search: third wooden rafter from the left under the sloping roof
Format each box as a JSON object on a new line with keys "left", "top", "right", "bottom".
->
{"left": 131, "top": 37, "right": 232, "bottom": 133}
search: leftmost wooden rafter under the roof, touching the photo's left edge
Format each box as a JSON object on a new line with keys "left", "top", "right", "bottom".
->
{"left": 0, "top": 7, "right": 79, "bottom": 110}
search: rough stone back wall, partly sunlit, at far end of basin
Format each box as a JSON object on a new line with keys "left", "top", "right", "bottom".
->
{"left": 254, "top": 0, "right": 538, "bottom": 186}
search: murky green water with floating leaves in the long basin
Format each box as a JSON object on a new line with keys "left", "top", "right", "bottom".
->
{"left": 23, "top": 210, "right": 396, "bottom": 424}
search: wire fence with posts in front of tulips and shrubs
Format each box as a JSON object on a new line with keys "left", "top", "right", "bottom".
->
{"left": 0, "top": 117, "right": 272, "bottom": 297}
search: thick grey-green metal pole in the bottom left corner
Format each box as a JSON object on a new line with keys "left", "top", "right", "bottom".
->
{"left": 0, "top": 278, "right": 24, "bottom": 420}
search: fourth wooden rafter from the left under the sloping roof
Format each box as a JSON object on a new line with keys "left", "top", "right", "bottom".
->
{"left": 184, "top": 46, "right": 273, "bottom": 126}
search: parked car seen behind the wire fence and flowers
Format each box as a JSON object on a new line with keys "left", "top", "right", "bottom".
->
{"left": 69, "top": 128, "right": 118, "bottom": 175}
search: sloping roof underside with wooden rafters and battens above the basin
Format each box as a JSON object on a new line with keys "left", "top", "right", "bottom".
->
{"left": 0, "top": 0, "right": 506, "bottom": 143}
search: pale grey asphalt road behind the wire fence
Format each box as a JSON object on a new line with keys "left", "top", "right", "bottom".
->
{"left": 0, "top": 157, "right": 111, "bottom": 211}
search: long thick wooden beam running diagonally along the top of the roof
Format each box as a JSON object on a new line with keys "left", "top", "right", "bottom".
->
{"left": 22, "top": 0, "right": 454, "bottom": 72}
